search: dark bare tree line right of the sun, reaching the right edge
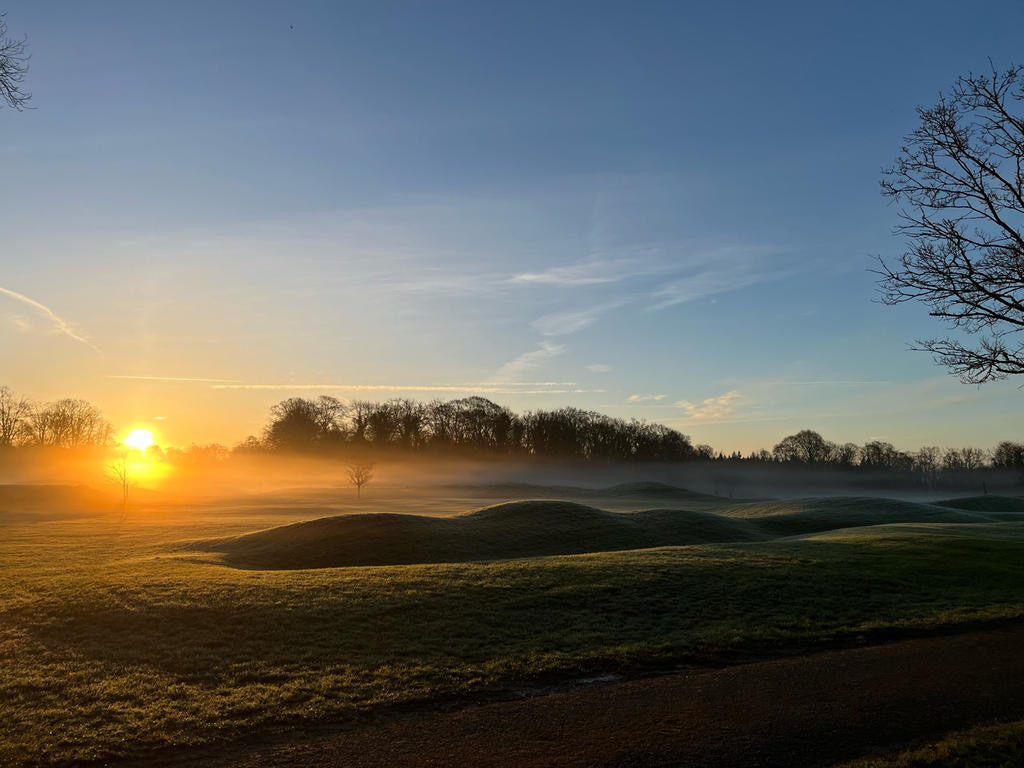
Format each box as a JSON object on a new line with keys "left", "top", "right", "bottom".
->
{"left": 237, "top": 395, "right": 1024, "bottom": 474}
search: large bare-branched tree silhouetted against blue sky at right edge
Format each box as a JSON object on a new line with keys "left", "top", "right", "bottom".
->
{"left": 880, "top": 67, "right": 1024, "bottom": 384}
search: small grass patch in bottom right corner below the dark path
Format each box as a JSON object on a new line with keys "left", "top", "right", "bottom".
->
{"left": 843, "top": 721, "right": 1024, "bottom": 768}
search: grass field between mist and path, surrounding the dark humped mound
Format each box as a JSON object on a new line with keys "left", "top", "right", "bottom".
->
{"left": 6, "top": 488, "right": 1024, "bottom": 765}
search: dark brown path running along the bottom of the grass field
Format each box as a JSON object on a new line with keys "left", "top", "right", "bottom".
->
{"left": 123, "top": 625, "right": 1024, "bottom": 768}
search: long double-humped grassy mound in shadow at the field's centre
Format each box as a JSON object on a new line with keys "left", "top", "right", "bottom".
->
{"left": 200, "top": 500, "right": 760, "bottom": 569}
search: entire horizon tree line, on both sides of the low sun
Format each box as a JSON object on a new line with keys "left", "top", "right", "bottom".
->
{"left": 0, "top": 386, "right": 1024, "bottom": 478}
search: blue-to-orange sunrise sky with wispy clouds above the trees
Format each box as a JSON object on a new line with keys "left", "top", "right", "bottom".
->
{"left": 0, "top": 0, "right": 1024, "bottom": 452}
